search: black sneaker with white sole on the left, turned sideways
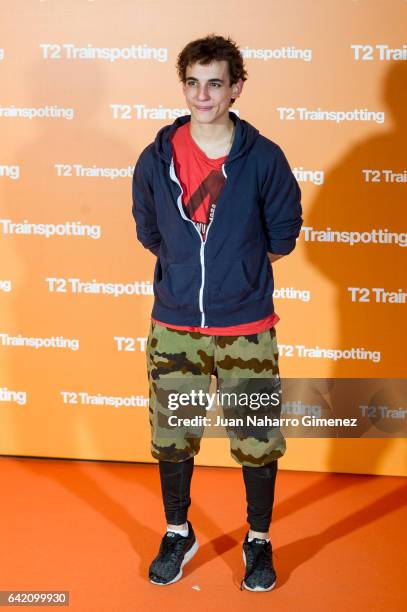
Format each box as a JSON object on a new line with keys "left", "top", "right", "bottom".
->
{"left": 149, "top": 521, "right": 198, "bottom": 585}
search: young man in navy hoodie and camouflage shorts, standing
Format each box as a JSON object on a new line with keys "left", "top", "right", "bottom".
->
{"left": 133, "top": 35, "right": 302, "bottom": 591}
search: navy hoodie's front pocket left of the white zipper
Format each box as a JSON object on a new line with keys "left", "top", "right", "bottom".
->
{"left": 155, "top": 264, "right": 201, "bottom": 308}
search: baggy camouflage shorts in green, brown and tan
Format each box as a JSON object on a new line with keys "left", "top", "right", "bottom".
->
{"left": 146, "top": 322, "right": 286, "bottom": 467}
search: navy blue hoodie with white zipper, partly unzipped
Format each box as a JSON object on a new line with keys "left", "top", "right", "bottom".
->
{"left": 133, "top": 111, "right": 302, "bottom": 327}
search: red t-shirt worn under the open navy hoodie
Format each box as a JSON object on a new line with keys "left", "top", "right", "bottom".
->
{"left": 152, "top": 122, "right": 280, "bottom": 336}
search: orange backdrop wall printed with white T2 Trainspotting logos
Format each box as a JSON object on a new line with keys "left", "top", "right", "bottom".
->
{"left": 0, "top": 0, "right": 407, "bottom": 474}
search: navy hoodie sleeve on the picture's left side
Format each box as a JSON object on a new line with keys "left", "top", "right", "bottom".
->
{"left": 132, "top": 150, "right": 161, "bottom": 256}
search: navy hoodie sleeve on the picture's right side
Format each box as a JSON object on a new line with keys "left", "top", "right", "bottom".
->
{"left": 261, "top": 145, "right": 303, "bottom": 255}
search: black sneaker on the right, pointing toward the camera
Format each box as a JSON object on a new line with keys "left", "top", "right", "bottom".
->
{"left": 240, "top": 533, "right": 276, "bottom": 591}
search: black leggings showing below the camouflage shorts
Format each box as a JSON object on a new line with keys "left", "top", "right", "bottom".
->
{"left": 158, "top": 457, "right": 277, "bottom": 533}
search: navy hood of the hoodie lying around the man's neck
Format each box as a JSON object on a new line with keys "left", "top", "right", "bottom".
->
{"left": 154, "top": 111, "right": 259, "bottom": 164}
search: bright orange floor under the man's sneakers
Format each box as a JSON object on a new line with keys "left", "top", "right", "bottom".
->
{"left": 0, "top": 457, "right": 407, "bottom": 612}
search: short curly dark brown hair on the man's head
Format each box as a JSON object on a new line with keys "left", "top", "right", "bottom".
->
{"left": 176, "top": 33, "right": 248, "bottom": 104}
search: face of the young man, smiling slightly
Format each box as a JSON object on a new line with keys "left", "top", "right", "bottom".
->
{"left": 182, "top": 60, "right": 243, "bottom": 123}
